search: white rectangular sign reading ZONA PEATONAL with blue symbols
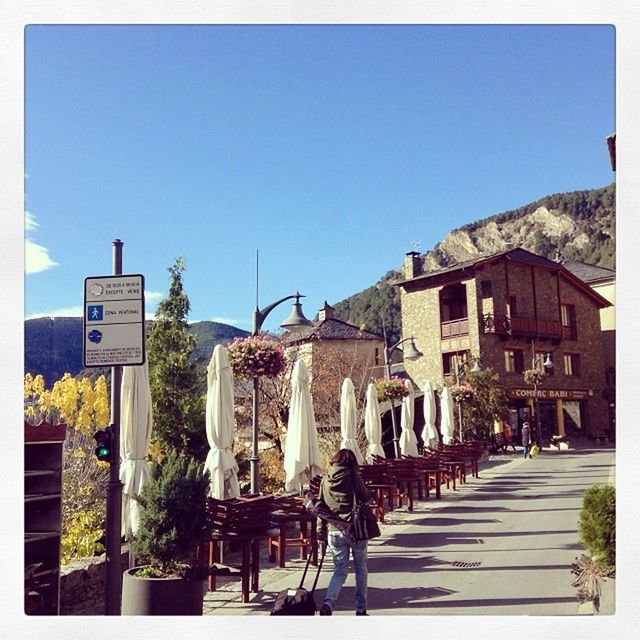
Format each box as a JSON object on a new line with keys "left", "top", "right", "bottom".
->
{"left": 82, "top": 273, "right": 145, "bottom": 367}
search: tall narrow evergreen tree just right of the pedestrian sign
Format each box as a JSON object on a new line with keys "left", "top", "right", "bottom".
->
{"left": 147, "top": 257, "right": 209, "bottom": 462}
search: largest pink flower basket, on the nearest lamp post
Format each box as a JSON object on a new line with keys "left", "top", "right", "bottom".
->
{"left": 227, "top": 336, "right": 287, "bottom": 379}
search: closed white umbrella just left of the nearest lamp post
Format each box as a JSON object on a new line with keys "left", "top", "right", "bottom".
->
{"left": 204, "top": 344, "right": 240, "bottom": 500}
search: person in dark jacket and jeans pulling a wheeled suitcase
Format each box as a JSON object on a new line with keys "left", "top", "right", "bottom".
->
{"left": 318, "top": 449, "right": 370, "bottom": 616}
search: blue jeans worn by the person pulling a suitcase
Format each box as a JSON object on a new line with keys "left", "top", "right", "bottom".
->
{"left": 324, "top": 531, "right": 367, "bottom": 611}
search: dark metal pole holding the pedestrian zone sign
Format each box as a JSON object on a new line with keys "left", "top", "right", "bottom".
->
{"left": 105, "top": 240, "right": 124, "bottom": 616}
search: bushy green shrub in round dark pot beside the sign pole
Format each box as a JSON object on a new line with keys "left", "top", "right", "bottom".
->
{"left": 122, "top": 453, "right": 209, "bottom": 615}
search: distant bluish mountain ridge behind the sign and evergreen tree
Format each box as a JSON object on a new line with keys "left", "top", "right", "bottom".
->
{"left": 24, "top": 318, "right": 249, "bottom": 386}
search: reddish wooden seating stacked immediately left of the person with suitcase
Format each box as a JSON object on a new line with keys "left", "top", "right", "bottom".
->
{"left": 269, "top": 496, "right": 318, "bottom": 567}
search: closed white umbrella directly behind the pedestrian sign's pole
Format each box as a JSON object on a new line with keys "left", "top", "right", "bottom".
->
{"left": 120, "top": 362, "right": 153, "bottom": 537}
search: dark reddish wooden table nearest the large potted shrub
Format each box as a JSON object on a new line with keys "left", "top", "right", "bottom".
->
{"left": 204, "top": 529, "right": 278, "bottom": 602}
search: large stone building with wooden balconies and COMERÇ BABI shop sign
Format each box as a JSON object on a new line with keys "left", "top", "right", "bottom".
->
{"left": 397, "top": 248, "right": 610, "bottom": 440}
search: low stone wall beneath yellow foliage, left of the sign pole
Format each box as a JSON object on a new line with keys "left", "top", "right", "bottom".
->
{"left": 60, "top": 551, "right": 129, "bottom": 616}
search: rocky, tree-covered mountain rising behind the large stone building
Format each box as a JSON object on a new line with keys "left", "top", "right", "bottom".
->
{"left": 334, "top": 184, "right": 616, "bottom": 343}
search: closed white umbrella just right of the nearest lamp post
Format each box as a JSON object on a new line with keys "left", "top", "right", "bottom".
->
{"left": 284, "top": 360, "right": 324, "bottom": 491}
